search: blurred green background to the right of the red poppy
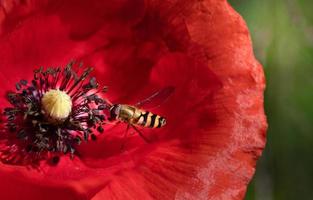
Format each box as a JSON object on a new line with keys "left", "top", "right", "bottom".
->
{"left": 229, "top": 0, "right": 313, "bottom": 200}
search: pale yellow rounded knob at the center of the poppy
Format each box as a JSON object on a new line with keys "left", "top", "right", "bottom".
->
{"left": 41, "top": 90, "right": 72, "bottom": 120}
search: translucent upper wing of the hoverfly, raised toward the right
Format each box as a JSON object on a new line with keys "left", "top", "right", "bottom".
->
{"left": 135, "top": 86, "right": 175, "bottom": 109}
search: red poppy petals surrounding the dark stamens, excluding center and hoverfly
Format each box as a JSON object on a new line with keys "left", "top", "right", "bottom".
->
{"left": 0, "top": 0, "right": 266, "bottom": 200}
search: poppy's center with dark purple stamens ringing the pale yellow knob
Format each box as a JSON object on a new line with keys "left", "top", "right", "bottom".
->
{"left": 4, "top": 62, "right": 109, "bottom": 161}
